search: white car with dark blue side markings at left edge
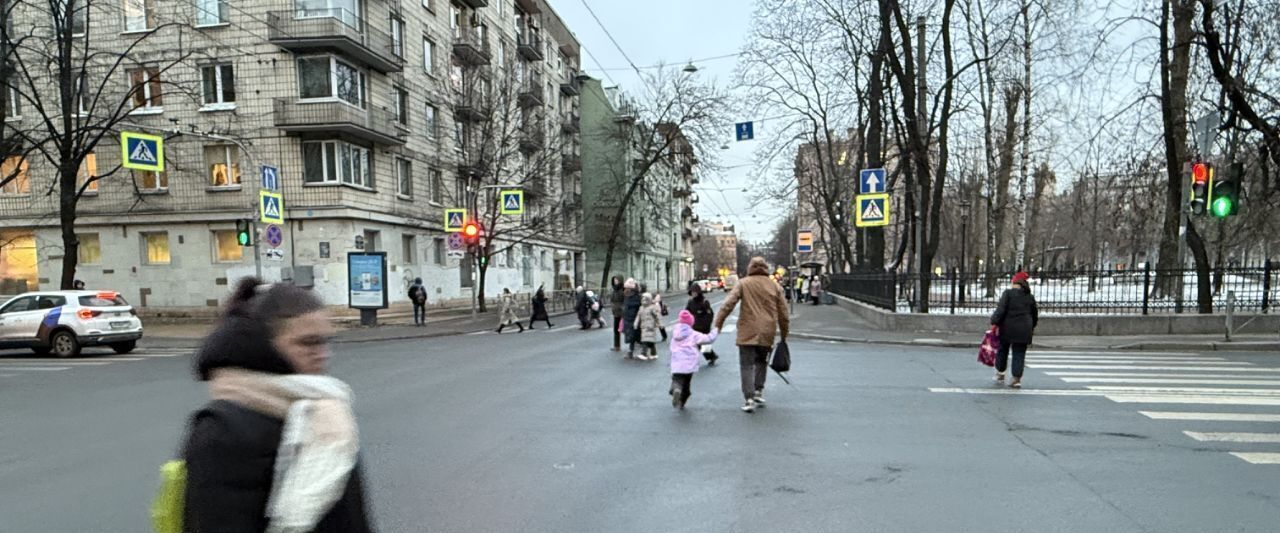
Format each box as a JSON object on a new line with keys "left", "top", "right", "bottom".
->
{"left": 0, "top": 291, "right": 142, "bottom": 357}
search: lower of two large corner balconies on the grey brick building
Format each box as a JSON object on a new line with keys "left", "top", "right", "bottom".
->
{"left": 273, "top": 99, "right": 404, "bottom": 145}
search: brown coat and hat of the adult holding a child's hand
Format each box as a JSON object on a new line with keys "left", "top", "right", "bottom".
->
{"left": 716, "top": 258, "right": 791, "bottom": 346}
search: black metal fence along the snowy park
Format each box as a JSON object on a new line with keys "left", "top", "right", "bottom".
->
{"left": 828, "top": 261, "right": 1280, "bottom": 315}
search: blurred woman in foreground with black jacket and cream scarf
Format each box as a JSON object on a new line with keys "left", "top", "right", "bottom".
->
{"left": 183, "top": 278, "right": 372, "bottom": 533}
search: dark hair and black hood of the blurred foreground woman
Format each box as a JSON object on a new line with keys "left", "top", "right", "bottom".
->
{"left": 196, "top": 277, "right": 324, "bottom": 381}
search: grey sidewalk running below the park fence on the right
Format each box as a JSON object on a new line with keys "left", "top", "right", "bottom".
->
{"left": 791, "top": 304, "right": 1280, "bottom": 354}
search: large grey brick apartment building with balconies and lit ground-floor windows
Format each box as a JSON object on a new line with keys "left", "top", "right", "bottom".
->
{"left": 0, "top": 0, "right": 585, "bottom": 308}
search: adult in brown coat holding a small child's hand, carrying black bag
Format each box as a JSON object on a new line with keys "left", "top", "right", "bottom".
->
{"left": 716, "top": 258, "right": 791, "bottom": 413}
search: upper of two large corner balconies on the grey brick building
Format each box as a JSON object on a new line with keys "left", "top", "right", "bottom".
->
{"left": 266, "top": 9, "right": 404, "bottom": 73}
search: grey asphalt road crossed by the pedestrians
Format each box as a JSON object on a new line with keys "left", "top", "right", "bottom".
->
{"left": 0, "top": 302, "right": 1280, "bottom": 533}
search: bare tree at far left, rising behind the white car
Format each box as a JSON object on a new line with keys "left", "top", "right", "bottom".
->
{"left": 0, "top": 0, "right": 197, "bottom": 288}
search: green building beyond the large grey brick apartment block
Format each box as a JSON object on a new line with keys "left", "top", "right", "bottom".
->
{"left": 582, "top": 78, "right": 698, "bottom": 292}
